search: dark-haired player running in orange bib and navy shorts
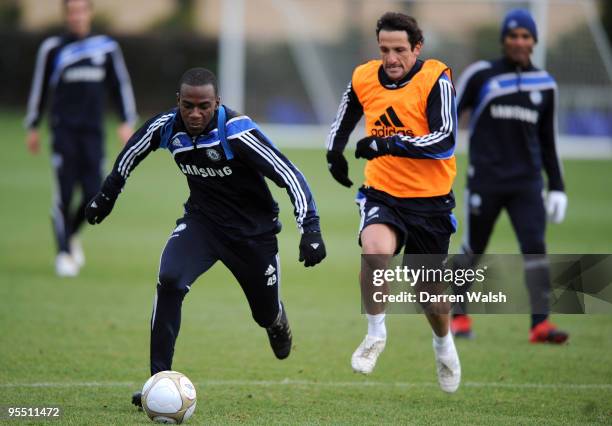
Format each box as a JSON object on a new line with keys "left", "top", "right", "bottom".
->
{"left": 327, "top": 12, "right": 461, "bottom": 392}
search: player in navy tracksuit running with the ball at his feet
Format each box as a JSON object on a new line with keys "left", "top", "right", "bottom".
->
{"left": 85, "top": 68, "right": 326, "bottom": 405}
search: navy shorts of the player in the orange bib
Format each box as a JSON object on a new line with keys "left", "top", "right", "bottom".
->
{"left": 355, "top": 188, "right": 457, "bottom": 254}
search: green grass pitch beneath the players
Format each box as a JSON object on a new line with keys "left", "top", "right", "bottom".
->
{"left": 0, "top": 112, "right": 612, "bottom": 424}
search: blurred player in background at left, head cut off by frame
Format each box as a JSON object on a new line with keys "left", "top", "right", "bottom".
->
{"left": 25, "top": 0, "right": 136, "bottom": 277}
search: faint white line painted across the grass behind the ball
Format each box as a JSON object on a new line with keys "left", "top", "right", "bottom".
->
{"left": 0, "top": 379, "right": 612, "bottom": 390}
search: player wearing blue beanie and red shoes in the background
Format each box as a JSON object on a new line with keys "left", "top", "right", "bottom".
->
{"left": 452, "top": 9, "right": 568, "bottom": 343}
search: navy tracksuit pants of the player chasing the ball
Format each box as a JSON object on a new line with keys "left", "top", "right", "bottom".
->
{"left": 151, "top": 213, "right": 280, "bottom": 374}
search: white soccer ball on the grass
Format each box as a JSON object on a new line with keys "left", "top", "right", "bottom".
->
{"left": 142, "top": 370, "right": 196, "bottom": 424}
